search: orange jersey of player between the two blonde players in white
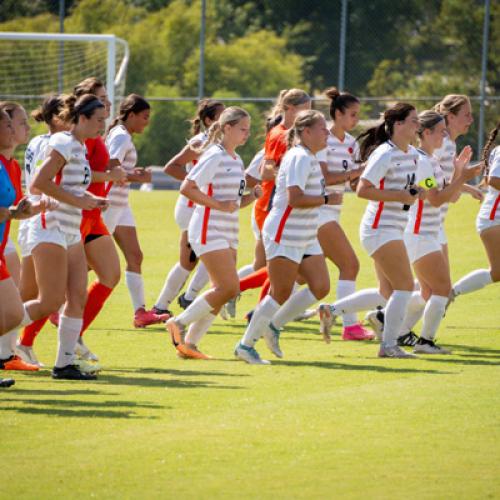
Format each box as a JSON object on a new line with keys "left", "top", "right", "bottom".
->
{"left": 254, "top": 124, "right": 288, "bottom": 230}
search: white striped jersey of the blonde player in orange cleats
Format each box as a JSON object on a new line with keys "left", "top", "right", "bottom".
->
{"left": 186, "top": 144, "right": 245, "bottom": 248}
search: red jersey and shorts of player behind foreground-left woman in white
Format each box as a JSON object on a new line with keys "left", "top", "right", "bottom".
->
{"left": 80, "top": 137, "right": 109, "bottom": 243}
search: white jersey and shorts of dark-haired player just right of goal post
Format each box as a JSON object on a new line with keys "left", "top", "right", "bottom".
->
{"left": 103, "top": 125, "right": 137, "bottom": 234}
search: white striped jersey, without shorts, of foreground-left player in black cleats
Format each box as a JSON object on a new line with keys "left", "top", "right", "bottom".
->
{"left": 36, "top": 132, "right": 91, "bottom": 236}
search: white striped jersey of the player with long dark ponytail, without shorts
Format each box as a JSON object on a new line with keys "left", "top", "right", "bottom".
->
{"left": 361, "top": 141, "right": 418, "bottom": 233}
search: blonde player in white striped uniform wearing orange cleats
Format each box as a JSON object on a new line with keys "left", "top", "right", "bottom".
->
{"left": 167, "top": 107, "right": 259, "bottom": 359}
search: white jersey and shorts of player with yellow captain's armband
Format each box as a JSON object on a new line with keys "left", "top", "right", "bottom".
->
{"left": 404, "top": 149, "right": 446, "bottom": 264}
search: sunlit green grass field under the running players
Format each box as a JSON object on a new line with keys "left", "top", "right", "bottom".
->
{"left": 0, "top": 192, "right": 500, "bottom": 499}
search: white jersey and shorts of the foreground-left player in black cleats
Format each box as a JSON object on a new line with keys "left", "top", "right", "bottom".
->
{"left": 28, "top": 132, "right": 91, "bottom": 251}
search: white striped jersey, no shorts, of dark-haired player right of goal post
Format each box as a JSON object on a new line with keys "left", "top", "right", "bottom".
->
{"left": 106, "top": 124, "right": 137, "bottom": 208}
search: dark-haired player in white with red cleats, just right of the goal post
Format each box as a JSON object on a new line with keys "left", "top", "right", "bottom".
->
{"left": 103, "top": 94, "right": 168, "bottom": 328}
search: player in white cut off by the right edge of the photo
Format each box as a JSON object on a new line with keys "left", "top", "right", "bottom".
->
{"left": 451, "top": 123, "right": 500, "bottom": 300}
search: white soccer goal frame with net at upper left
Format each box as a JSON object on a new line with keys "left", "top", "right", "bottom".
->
{"left": 0, "top": 32, "right": 129, "bottom": 116}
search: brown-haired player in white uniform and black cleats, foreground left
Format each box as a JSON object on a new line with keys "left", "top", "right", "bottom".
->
{"left": 24, "top": 95, "right": 107, "bottom": 380}
